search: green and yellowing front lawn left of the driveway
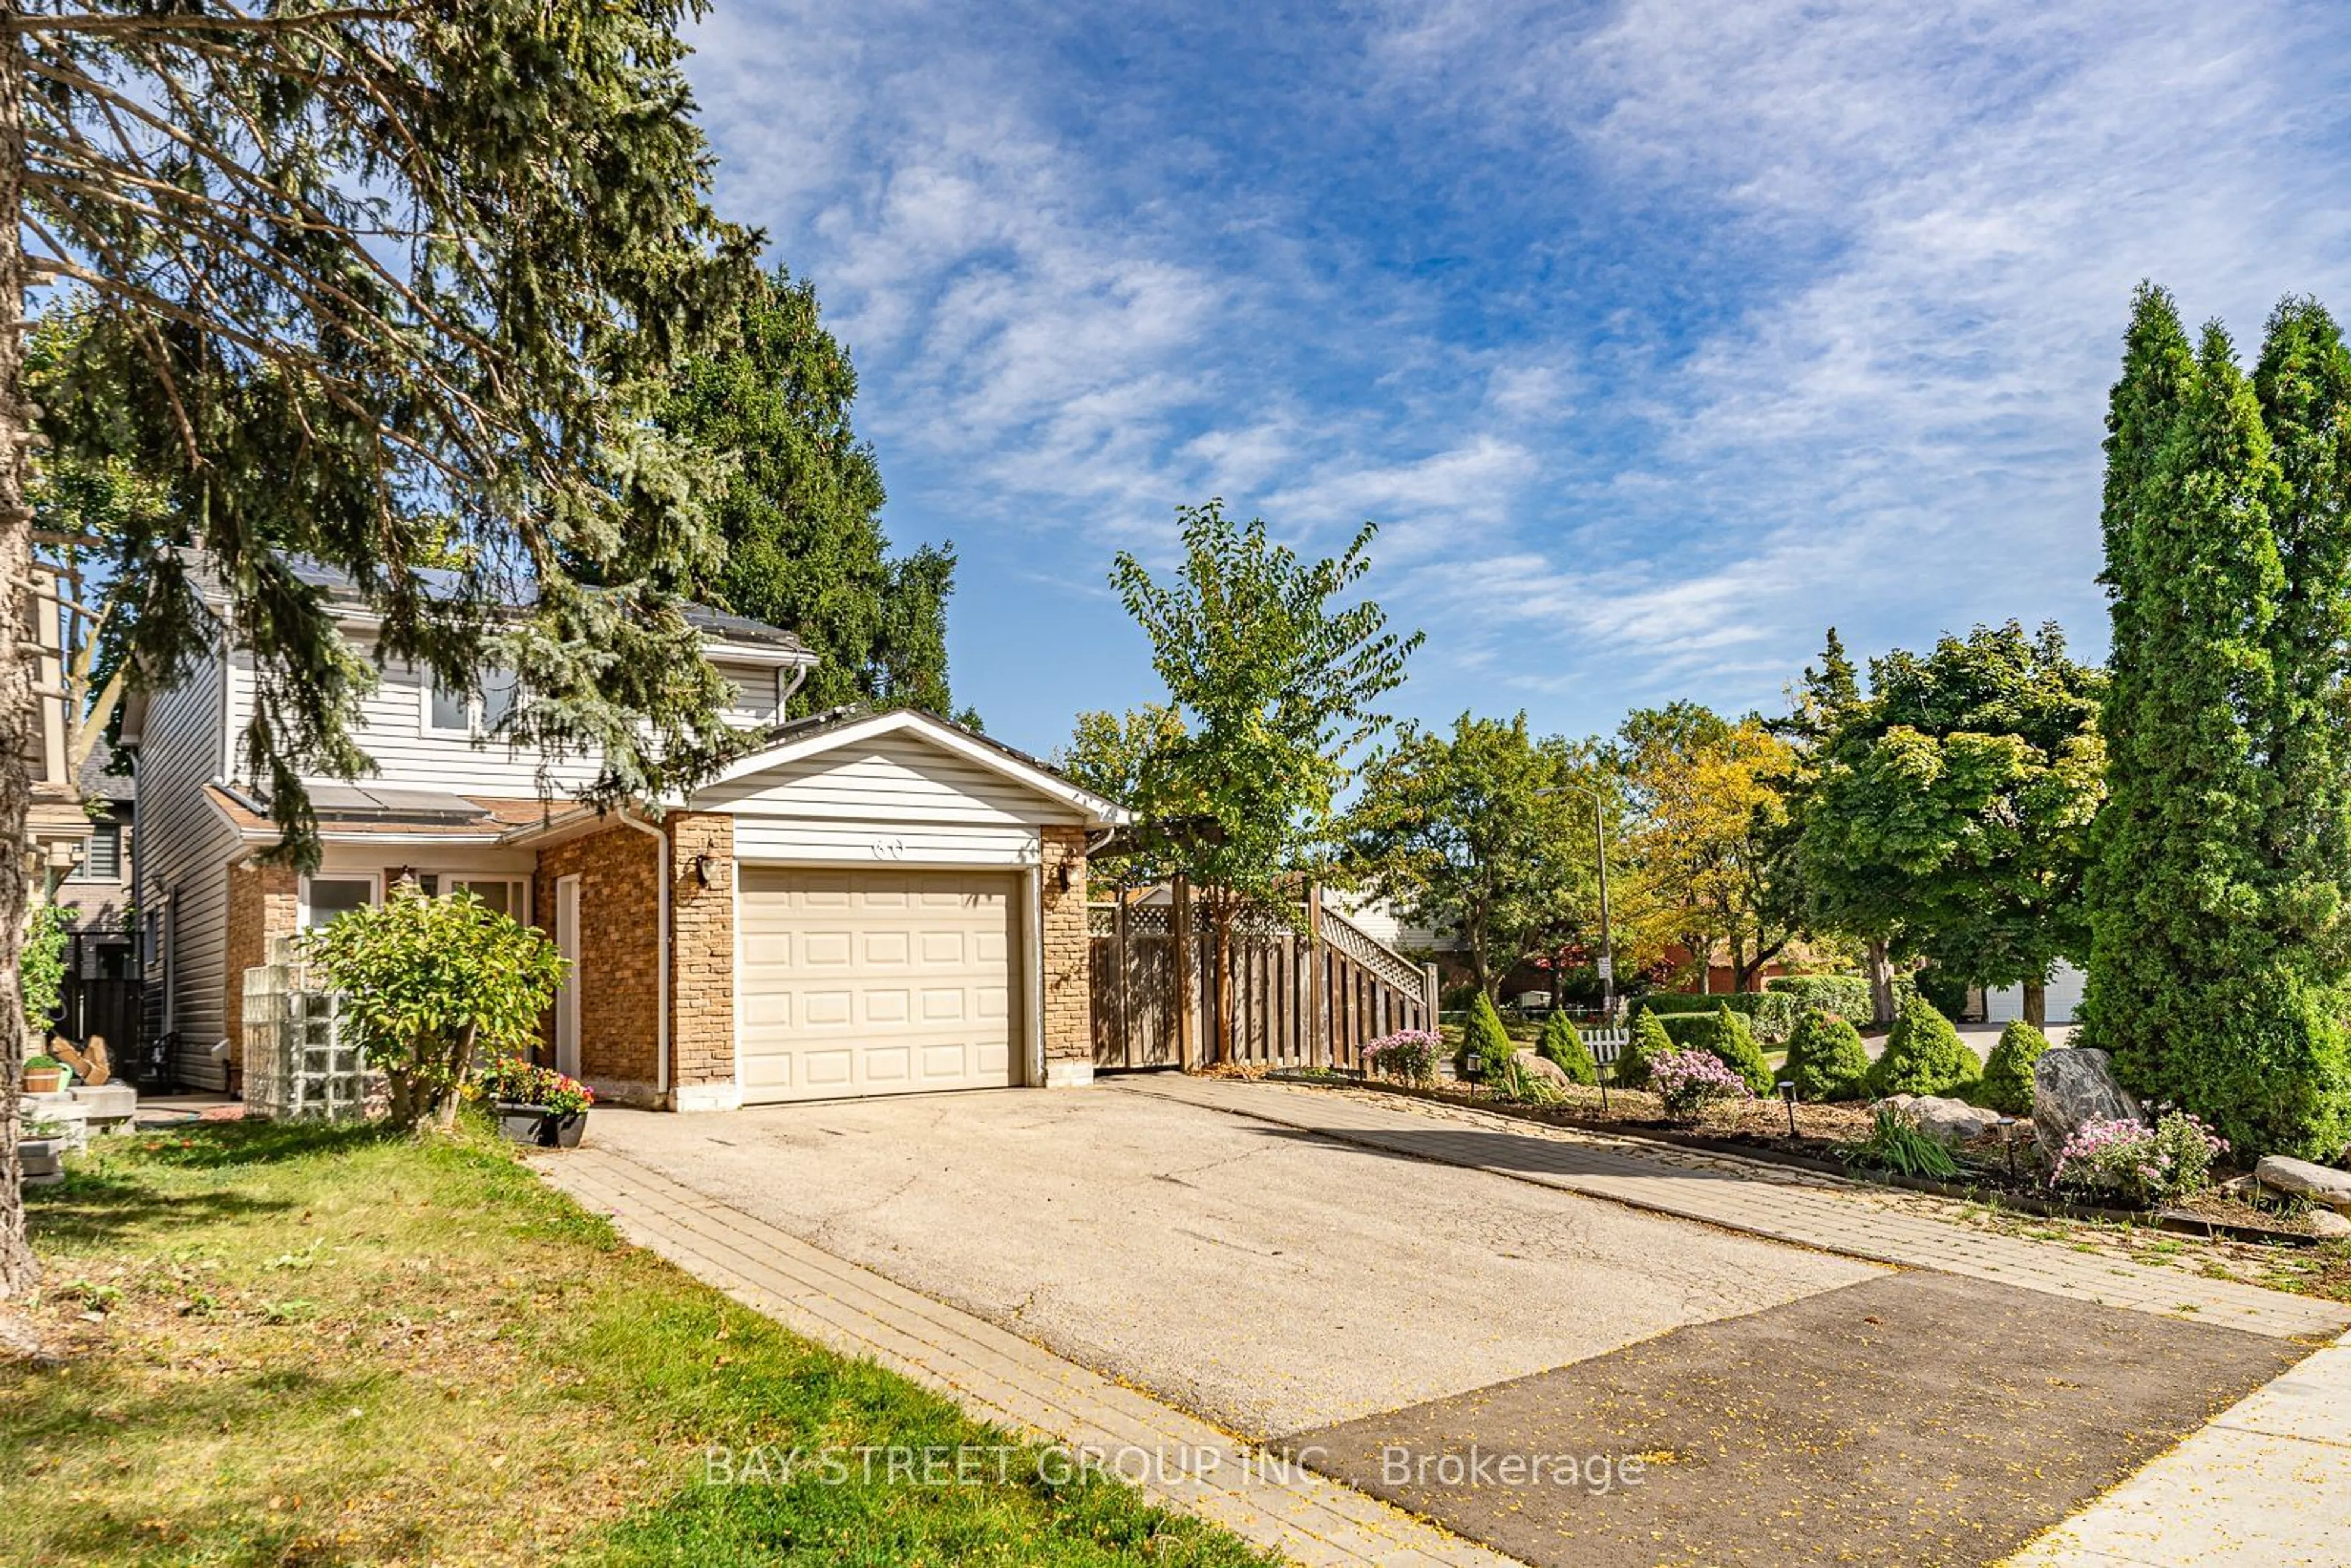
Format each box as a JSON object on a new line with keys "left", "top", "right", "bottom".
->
{"left": 0, "top": 1123, "right": 1262, "bottom": 1566}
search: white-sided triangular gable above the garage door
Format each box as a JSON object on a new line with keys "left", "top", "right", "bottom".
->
{"left": 694, "top": 736, "right": 1086, "bottom": 835}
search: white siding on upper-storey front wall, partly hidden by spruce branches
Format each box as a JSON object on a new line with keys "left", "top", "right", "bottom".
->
{"left": 228, "top": 644, "right": 776, "bottom": 799}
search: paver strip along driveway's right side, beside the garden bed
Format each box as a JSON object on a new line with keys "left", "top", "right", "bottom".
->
{"left": 1114, "top": 1075, "right": 2351, "bottom": 1345}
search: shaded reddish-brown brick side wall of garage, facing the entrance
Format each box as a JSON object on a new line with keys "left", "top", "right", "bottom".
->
{"left": 531, "top": 823, "right": 661, "bottom": 1105}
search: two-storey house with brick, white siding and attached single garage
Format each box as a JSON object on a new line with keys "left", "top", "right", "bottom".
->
{"left": 127, "top": 557, "right": 1124, "bottom": 1109}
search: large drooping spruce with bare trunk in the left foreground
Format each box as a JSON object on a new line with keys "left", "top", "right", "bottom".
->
{"left": 0, "top": 0, "right": 757, "bottom": 1297}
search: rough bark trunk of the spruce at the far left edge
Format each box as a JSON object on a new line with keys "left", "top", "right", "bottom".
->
{"left": 0, "top": 21, "right": 40, "bottom": 1300}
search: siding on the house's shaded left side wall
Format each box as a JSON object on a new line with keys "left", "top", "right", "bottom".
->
{"left": 139, "top": 663, "right": 238, "bottom": 1089}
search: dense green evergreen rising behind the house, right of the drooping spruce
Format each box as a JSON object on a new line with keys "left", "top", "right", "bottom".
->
{"left": 661, "top": 268, "right": 954, "bottom": 712}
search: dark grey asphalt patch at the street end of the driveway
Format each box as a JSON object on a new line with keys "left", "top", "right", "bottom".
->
{"left": 1281, "top": 1272, "right": 2306, "bottom": 1568}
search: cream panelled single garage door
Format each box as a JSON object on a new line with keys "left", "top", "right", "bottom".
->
{"left": 736, "top": 868, "right": 1021, "bottom": 1105}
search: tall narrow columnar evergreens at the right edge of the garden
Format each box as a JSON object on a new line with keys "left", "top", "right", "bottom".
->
{"left": 2083, "top": 287, "right": 2351, "bottom": 1154}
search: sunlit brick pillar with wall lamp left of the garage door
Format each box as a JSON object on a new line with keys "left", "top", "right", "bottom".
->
{"left": 663, "top": 811, "right": 743, "bottom": 1109}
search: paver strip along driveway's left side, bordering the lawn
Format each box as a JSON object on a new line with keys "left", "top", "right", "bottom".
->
{"left": 541, "top": 1147, "right": 1509, "bottom": 1568}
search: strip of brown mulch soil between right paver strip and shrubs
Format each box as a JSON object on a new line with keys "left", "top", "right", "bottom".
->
{"left": 1277, "top": 1075, "right": 2318, "bottom": 1246}
